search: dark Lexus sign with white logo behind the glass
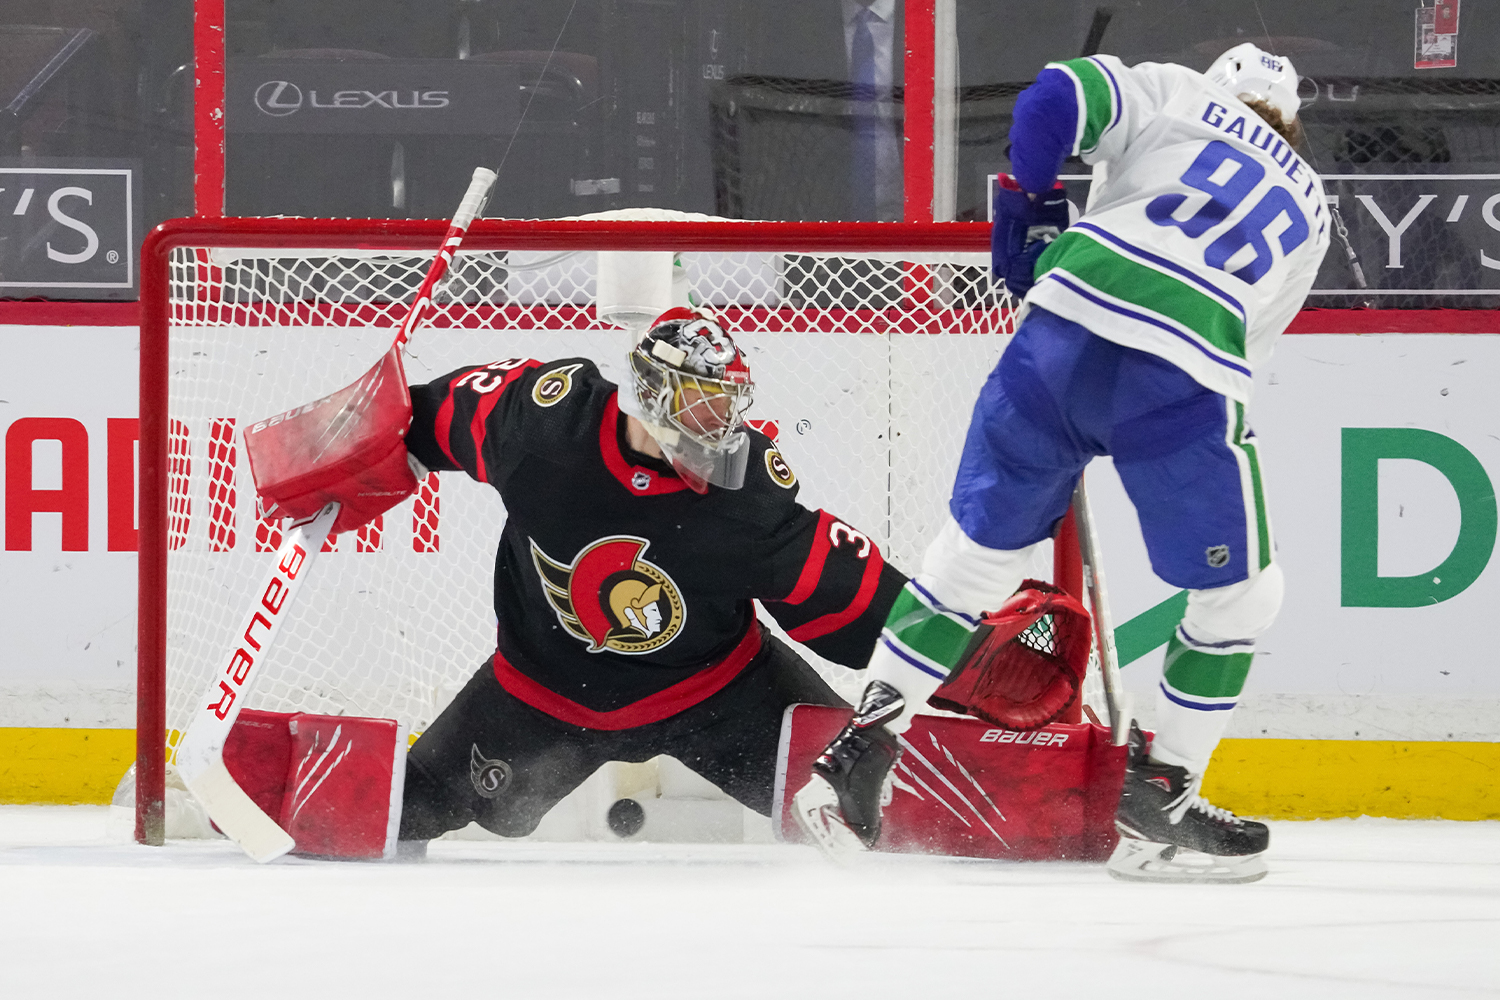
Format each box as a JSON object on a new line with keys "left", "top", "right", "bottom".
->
{"left": 225, "top": 58, "right": 521, "bottom": 135}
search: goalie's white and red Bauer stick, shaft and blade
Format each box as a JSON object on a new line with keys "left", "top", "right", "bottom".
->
{"left": 176, "top": 166, "right": 495, "bottom": 864}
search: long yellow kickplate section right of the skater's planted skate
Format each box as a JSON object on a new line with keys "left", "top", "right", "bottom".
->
{"left": 1203, "top": 739, "right": 1500, "bottom": 820}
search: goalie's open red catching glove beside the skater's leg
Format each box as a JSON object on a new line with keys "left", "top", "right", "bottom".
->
{"left": 929, "top": 580, "right": 1092, "bottom": 730}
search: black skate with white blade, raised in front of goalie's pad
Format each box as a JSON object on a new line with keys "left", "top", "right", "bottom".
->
{"left": 792, "top": 681, "right": 906, "bottom": 858}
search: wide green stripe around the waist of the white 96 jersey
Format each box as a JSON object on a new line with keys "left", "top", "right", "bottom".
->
{"left": 1037, "top": 229, "right": 1245, "bottom": 358}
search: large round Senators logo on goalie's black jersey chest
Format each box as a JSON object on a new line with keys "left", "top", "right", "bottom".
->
{"left": 531, "top": 535, "right": 687, "bottom": 657}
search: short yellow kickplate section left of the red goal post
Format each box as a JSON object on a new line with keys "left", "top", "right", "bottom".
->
{"left": 0, "top": 729, "right": 135, "bottom": 805}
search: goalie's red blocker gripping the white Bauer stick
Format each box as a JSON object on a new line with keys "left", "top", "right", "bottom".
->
{"left": 245, "top": 346, "right": 420, "bottom": 534}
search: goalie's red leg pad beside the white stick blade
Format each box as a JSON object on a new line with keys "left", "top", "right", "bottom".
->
{"left": 224, "top": 709, "right": 407, "bottom": 861}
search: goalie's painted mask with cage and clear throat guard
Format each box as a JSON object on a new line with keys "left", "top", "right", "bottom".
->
{"left": 630, "top": 307, "right": 755, "bottom": 493}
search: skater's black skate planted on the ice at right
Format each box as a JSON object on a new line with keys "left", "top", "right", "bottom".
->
{"left": 1106, "top": 724, "right": 1271, "bottom": 882}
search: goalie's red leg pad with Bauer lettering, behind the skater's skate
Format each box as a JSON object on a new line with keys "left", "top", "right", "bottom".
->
{"left": 776, "top": 705, "right": 1127, "bottom": 861}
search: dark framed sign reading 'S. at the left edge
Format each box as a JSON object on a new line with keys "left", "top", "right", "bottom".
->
{"left": 0, "top": 159, "right": 141, "bottom": 298}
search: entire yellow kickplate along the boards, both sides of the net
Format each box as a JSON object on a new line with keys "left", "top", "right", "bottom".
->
{"left": 0, "top": 729, "right": 1500, "bottom": 820}
